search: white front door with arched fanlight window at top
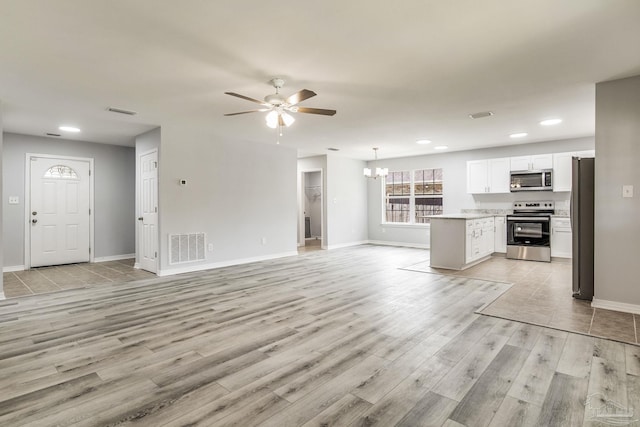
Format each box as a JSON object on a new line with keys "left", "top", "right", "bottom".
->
{"left": 29, "top": 157, "right": 90, "bottom": 267}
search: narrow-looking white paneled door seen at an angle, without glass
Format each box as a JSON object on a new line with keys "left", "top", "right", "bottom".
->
{"left": 138, "top": 151, "right": 158, "bottom": 273}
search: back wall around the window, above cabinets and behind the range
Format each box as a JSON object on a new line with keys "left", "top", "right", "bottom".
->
{"left": 368, "top": 137, "right": 599, "bottom": 247}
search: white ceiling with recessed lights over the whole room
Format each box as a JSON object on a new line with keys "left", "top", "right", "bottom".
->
{"left": 0, "top": 0, "right": 640, "bottom": 159}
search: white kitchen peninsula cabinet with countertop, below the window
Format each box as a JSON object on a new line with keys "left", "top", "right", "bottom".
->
{"left": 430, "top": 213, "right": 494, "bottom": 270}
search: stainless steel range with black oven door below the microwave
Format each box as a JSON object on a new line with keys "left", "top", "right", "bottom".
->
{"left": 507, "top": 200, "right": 555, "bottom": 262}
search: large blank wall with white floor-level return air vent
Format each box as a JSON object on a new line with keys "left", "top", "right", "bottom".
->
{"left": 159, "top": 125, "right": 297, "bottom": 275}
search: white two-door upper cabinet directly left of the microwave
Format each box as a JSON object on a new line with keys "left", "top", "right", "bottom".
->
{"left": 467, "top": 157, "right": 510, "bottom": 194}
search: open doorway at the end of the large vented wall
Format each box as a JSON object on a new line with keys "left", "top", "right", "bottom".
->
{"left": 298, "top": 169, "right": 325, "bottom": 250}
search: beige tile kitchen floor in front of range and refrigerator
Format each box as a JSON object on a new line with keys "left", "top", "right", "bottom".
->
{"left": 408, "top": 255, "right": 640, "bottom": 344}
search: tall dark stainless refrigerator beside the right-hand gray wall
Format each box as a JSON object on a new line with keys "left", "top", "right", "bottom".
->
{"left": 570, "top": 157, "right": 595, "bottom": 301}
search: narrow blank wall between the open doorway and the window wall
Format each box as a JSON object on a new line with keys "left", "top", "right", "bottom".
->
{"left": 325, "top": 156, "right": 368, "bottom": 249}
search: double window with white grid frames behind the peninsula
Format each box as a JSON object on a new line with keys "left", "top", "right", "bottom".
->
{"left": 384, "top": 169, "right": 442, "bottom": 224}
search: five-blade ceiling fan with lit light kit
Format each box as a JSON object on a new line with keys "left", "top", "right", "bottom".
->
{"left": 225, "top": 78, "right": 336, "bottom": 129}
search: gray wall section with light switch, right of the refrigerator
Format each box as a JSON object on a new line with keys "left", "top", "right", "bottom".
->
{"left": 594, "top": 76, "right": 640, "bottom": 306}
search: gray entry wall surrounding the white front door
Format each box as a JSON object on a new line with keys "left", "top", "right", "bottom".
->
{"left": 2, "top": 133, "right": 135, "bottom": 266}
